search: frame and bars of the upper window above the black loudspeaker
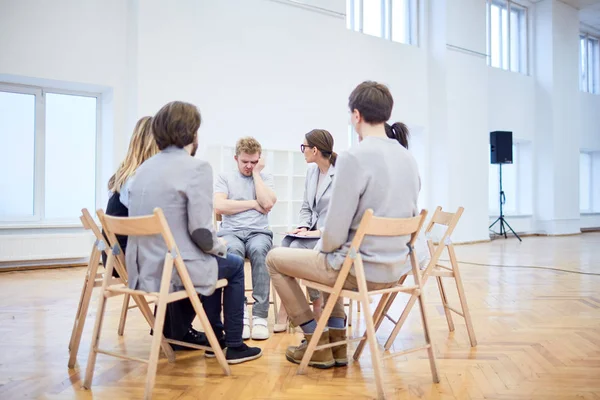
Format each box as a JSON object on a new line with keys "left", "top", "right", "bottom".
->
{"left": 486, "top": 0, "right": 530, "bottom": 76}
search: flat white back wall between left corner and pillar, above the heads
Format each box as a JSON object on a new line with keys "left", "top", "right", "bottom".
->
{"left": 138, "top": 0, "right": 427, "bottom": 155}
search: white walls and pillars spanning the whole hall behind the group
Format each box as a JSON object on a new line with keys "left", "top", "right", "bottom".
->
{"left": 0, "top": 0, "right": 600, "bottom": 266}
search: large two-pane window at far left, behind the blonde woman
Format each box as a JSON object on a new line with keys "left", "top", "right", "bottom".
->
{"left": 0, "top": 84, "right": 99, "bottom": 223}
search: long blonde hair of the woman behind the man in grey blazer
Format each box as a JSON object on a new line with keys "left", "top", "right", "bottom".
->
{"left": 108, "top": 117, "right": 159, "bottom": 193}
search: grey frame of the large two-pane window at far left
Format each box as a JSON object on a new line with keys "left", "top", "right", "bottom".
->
{"left": 0, "top": 81, "right": 103, "bottom": 225}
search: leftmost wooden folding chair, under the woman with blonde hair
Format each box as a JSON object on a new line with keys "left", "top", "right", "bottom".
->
{"left": 68, "top": 208, "right": 134, "bottom": 368}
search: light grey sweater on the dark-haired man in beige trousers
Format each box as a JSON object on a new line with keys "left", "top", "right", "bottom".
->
{"left": 316, "top": 136, "right": 421, "bottom": 283}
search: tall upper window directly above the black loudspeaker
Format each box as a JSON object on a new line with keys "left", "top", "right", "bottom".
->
{"left": 487, "top": 0, "right": 528, "bottom": 74}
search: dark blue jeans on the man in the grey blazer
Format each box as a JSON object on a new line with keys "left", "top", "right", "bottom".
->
{"left": 202, "top": 254, "right": 244, "bottom": 347}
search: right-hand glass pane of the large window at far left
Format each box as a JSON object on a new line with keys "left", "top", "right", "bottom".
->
{"left": 45, "top": 93, "right": 96, "bottom": 219}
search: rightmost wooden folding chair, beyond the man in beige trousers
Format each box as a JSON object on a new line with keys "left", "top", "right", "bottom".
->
{"left": 385, "top": 207, "right": 477, "bottom": 349}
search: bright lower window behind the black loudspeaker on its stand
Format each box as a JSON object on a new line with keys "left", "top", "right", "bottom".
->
{"left": 488, "top": 142, "right": 533, "bottom": 216}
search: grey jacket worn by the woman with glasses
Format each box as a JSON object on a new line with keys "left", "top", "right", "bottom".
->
{"left": 298, "top": 164, "right": 335, "bottom": 231}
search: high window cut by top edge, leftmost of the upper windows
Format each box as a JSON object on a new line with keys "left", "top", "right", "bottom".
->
{"left": 346, "top": 0, "right": 417, "bottom": 44}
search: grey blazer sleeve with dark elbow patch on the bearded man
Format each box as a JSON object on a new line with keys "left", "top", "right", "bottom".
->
{"left": 186, "top": 162, "right": 227, "bottom": 258}
